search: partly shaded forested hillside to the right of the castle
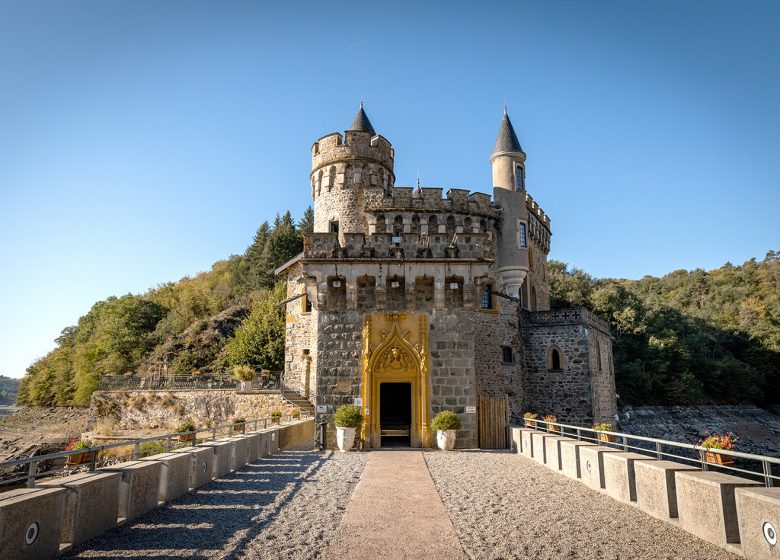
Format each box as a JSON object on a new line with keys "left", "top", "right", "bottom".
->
{"left": 550, "top": 251, "right": 780, "bottom": 404}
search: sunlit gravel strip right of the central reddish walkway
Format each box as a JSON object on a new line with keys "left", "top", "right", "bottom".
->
{"left": 425, "top": 451, "right": 739, "bottom": 560}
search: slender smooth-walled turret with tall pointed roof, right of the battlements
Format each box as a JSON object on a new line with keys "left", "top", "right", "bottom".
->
{"left": 490, "top": 107, "right": 528, "bottom": 296}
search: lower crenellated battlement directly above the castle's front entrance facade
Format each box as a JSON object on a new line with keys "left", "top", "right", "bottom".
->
{"left": 303, "top": 233, "right": 494, "bottom": 261}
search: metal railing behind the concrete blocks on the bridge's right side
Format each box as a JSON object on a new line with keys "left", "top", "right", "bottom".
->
{"left": 510, "top": 415, "right": 780, "bottom": 487}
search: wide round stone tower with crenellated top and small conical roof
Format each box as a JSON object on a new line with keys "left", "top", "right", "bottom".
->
{"left": 309, "top": 102, "right": 395, "bottom": 243}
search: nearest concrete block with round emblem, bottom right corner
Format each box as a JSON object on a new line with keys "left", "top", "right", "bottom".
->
{"left": 734, "top": 488, "right": 780, "bottom": 560}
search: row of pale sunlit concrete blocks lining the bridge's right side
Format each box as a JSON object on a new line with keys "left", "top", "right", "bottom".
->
{"left": 511, "top": 427, "right": 780, "bottom": 560}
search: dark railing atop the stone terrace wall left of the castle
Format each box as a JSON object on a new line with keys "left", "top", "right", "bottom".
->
{"left": 98, "top": 371, "right": 281, "bottom": 391}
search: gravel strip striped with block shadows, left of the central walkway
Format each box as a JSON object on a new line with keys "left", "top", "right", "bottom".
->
{"left": 68, "top": 451, "right": 366, "bottom": 560}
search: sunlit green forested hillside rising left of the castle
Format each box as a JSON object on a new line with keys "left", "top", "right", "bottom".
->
{"left": 17, "top": 208, "right": 314, "bottom": 406}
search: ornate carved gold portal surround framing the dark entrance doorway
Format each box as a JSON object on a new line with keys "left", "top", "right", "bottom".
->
{"left": 361, "top": 313, "right": 431, "bottom": 448}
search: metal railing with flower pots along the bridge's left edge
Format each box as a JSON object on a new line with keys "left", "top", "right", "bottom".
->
{"left": 0, "top": 413, "right": 309, "bottom": 488}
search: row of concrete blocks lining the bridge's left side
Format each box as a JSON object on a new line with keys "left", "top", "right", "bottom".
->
{"left": 0, "top": 418, "right": 314, "bottom": 560}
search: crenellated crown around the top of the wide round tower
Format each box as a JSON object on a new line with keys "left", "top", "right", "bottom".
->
{"left": 311, "top": 130, "right": 395, "bottom": 176}
